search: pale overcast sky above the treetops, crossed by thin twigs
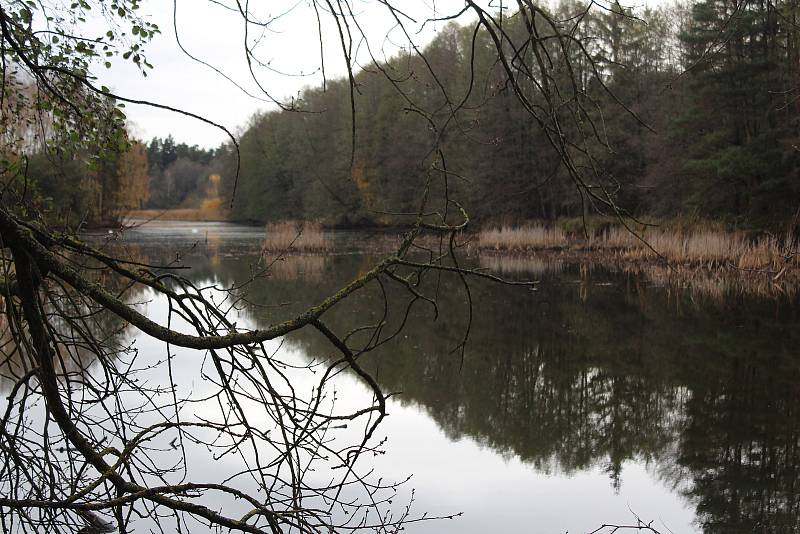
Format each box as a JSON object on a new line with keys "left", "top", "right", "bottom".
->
{"left": 96, "top": 0, "right": 494, "bottom": 147}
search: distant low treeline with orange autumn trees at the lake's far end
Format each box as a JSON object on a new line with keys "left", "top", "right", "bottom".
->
{"left": 10, "top": 124, "right": 227, "bottom": 223}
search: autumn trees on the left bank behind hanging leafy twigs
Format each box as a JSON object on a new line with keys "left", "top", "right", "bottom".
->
{"left": 0, "top": 75, "right": 149, "bottom": 228}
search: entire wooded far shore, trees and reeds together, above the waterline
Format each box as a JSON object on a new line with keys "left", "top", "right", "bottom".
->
{"left": 30, "top": 0, "right": 800, "bottom": 292}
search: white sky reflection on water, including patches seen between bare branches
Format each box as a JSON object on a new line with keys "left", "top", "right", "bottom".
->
{"left": 130, "top": 288, "right": 693, "bottom": 534}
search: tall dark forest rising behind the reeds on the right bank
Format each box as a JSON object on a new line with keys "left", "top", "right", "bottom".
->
{"left": 212, "top": 0, "right": 800, "bottom": 225}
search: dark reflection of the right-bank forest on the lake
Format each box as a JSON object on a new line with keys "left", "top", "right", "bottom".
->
{"left": 89, "top": 224, "right": 800, "bottom": 532}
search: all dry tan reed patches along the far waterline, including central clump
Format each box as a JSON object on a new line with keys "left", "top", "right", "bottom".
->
{"left": 123, "top": 209, "right": 800, "bottom": 281}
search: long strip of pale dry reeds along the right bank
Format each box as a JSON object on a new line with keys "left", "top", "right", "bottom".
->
{"left": 478, "top": 226, "right": 797, "bottom": 273}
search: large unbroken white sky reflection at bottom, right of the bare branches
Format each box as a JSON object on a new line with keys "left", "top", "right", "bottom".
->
{"left": 366, "top": 405, "right": 693, "bottom": 532}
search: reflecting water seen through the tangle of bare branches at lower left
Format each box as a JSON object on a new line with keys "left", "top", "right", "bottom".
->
{"left": 6, "top": 242, "right": 438, "bottom": 532}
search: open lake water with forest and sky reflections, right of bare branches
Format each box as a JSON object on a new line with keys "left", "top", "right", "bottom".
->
{"left": 92, "top": 223, "right": 800, "bottom": 533}
